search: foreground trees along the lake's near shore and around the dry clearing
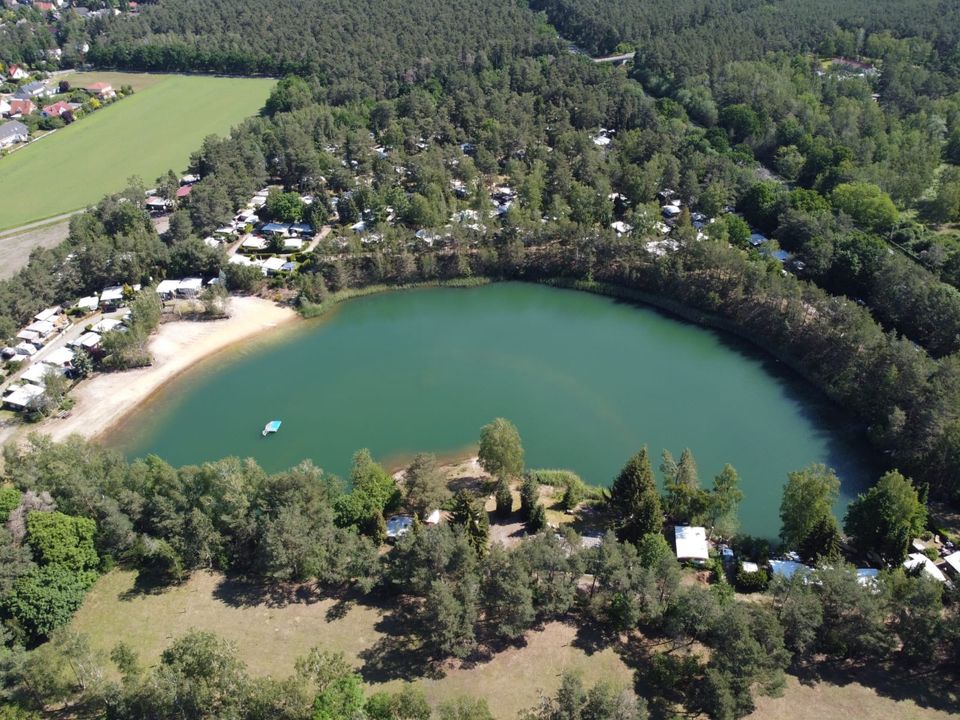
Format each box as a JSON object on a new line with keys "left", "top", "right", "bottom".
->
{"left": 0, "top": 428, "right": 960, "bottom": 720}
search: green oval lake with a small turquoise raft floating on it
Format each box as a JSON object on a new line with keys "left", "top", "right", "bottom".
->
{"left": 114, "top": 283, "right": 876, "bottom": 537}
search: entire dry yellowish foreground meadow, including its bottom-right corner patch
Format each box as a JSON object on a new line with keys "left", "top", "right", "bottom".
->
{"left": 72, "top": 570, "right": 956, "bottom": 720}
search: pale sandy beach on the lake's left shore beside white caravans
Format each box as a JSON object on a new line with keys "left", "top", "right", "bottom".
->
{"left": 21, "top": 297, "right": 298, "bottom": 440}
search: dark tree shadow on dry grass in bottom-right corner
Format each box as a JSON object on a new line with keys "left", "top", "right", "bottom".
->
{"left": 790, "top": 663, "right": 960, "bottom": 716}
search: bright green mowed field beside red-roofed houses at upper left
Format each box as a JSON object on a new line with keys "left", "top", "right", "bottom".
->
{"left": 0, "top": 73, "right": 274, "bottom": 230}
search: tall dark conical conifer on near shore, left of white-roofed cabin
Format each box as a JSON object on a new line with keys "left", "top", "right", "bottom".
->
{"left": 607, "top": 447, "right": 663, "bottom": 544}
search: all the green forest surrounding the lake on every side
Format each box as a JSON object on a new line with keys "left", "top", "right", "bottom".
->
{"left": 0, "top": 0, "right": 960, "bottom": 720}
